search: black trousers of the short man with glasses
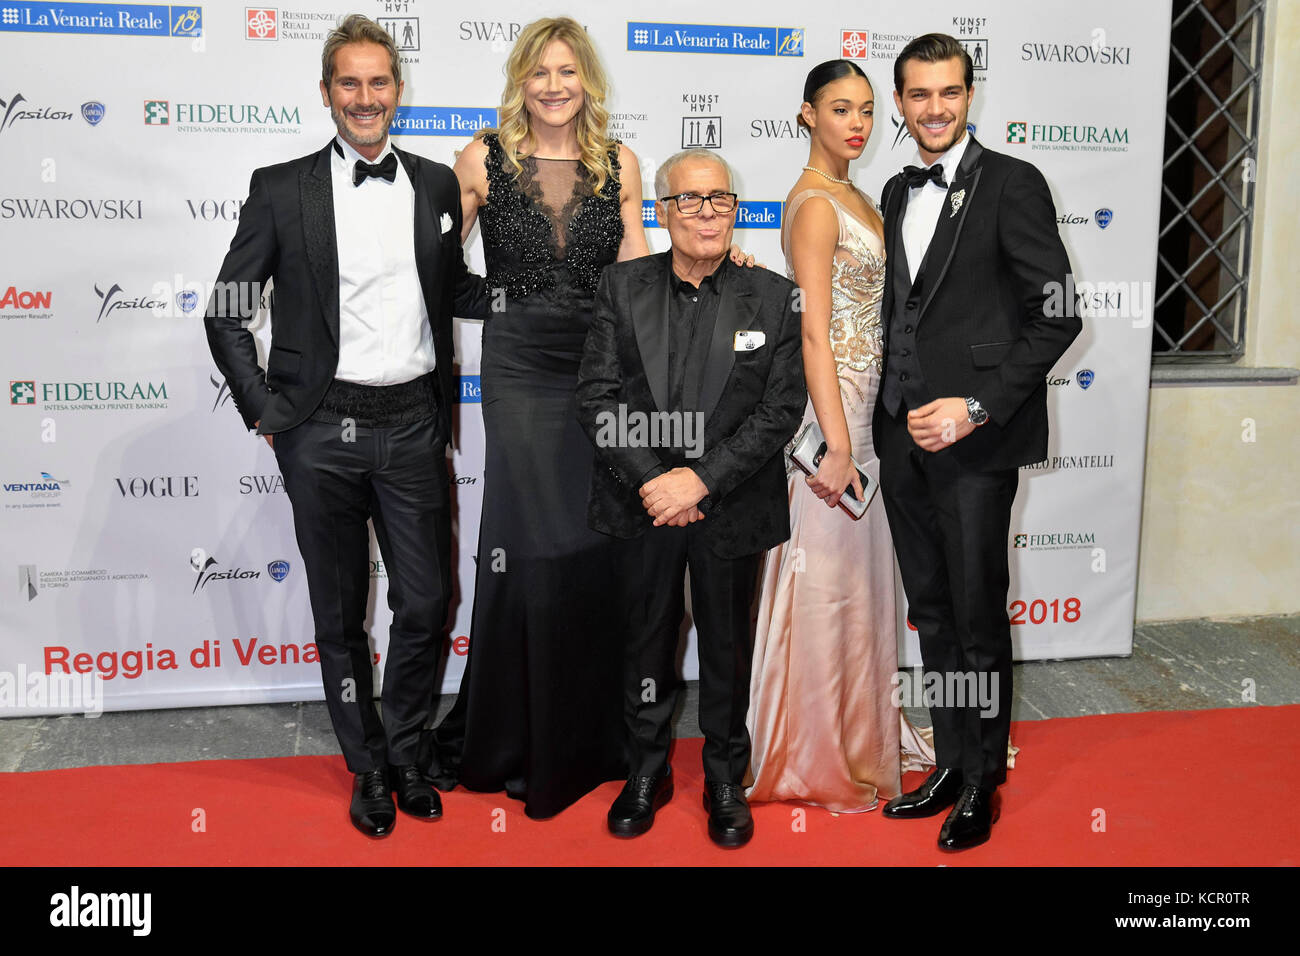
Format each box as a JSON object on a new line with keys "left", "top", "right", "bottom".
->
{"left": 623, "top": 518, "right": 762, "bottom": 784}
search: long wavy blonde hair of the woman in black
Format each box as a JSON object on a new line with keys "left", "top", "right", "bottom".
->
{"left": 488, "top": 17, "right": 615, "bottom": 194}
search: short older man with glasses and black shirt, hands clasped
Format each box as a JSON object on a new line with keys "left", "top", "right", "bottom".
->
{"left": 577, "top": 150, "right": 807, "bottom": 847}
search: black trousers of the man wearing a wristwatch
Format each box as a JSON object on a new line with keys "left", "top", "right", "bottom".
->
{"left": 876, "top": 408, "right": 1019, "bottom": 787}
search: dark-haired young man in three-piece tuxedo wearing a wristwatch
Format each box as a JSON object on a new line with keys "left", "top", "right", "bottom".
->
{"left": 872, "top": 34, "right": 1080, "bottom": 849}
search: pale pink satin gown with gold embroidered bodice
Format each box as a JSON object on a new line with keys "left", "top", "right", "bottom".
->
{"left": 748, "top": 189, "right": 935, "bottom": 813}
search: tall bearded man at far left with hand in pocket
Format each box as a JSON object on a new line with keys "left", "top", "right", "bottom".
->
{"left": 205, "top": 14, "right": 486, "bottom": 836}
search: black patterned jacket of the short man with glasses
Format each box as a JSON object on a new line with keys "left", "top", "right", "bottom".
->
{"left": 577, "top": 252, "right": 807, "bottom": 558}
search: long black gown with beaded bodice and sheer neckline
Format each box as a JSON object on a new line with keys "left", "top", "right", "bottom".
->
{"left": 437, "top": 134, "right": 628, "bottom": 817}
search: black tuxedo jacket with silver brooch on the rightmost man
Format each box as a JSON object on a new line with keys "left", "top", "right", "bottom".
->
{"left": 872, "top": 134, "right": 1082, "bottom": 471}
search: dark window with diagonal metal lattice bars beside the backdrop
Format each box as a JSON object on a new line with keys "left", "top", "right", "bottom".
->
{"left": 1152, "top": 0, "right": 1265, "bottom": 362}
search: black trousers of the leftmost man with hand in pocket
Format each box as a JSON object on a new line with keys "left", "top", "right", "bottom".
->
{"left": 274, "top": 418, "right": 451, "bottom": 774}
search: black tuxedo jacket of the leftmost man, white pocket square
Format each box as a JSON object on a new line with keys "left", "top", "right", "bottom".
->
{"left": 204, "top": 140, "right": 488, "bottom": 437}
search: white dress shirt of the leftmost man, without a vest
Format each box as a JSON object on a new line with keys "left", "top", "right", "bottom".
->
{"left": 330, "top": 137, "right": 436, "bottom": 385}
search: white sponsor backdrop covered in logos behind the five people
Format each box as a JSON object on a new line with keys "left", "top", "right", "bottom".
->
{"left": 0, "top": 0, "right": 1170, "bottom": 715}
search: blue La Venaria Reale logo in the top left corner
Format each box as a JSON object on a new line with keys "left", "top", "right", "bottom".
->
{"left": 0, "top": 0, "right": 203, "bottom": 36}
